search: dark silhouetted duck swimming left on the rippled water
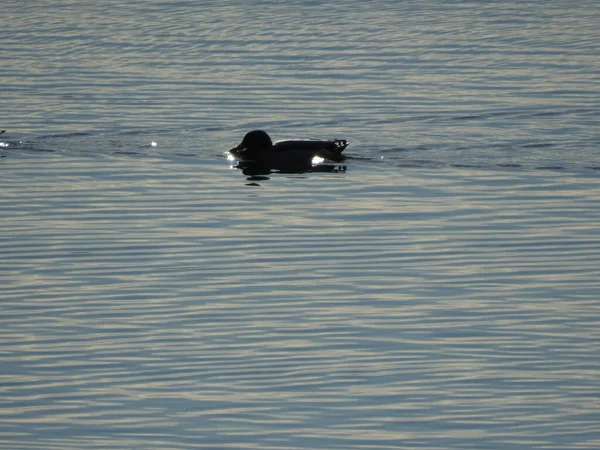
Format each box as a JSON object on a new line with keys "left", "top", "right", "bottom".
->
{"left": 228, "top": 130, "right": 348, "bottom": 172}
